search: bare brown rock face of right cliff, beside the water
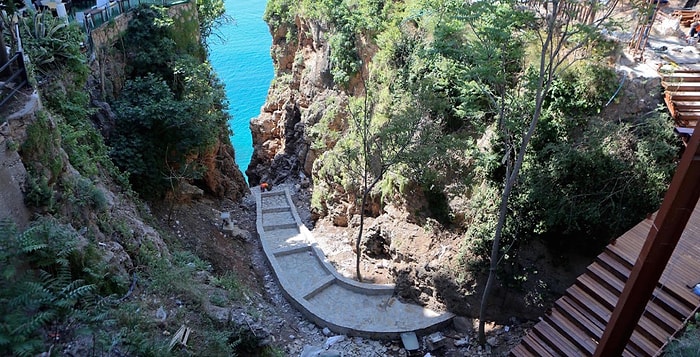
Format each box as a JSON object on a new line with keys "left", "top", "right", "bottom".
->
{"left": 246, "top": 17, "right": 347, "bottom": 185}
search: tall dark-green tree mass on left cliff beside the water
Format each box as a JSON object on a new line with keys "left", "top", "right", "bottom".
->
{"left": 110, "top": 1, "right": 229, "bottom": 198}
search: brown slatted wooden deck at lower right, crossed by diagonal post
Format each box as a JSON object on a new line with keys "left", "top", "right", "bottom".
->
{"left": 510, "top": 205, "right": 700, "bottom": 357}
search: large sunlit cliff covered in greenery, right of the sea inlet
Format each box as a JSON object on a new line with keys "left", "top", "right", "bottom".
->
{"left": 254, "top": 0, "right": 679, "bottom": 321}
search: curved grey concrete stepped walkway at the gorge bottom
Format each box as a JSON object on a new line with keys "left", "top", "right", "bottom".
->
{"left": 252, "top": 187, "right": 454, "bottom": 339}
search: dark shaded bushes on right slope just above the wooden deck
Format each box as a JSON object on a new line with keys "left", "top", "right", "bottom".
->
{"left": 513, "top": 114, "right": 677, "bottom": 250}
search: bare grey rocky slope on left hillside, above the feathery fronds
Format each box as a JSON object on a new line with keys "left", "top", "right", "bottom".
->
{"left": 0, "top": 92, "right": 170, "bottom": 281}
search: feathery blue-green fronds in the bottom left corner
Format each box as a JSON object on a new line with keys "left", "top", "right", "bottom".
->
{"left": 0, "top": 219, "right": 95, "bottom": 356}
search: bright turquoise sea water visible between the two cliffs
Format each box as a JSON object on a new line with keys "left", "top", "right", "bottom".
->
{"left": 209, "top": 0, "right": 274, "bottom": 179}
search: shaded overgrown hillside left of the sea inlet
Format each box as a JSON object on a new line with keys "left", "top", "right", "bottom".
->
{"left": 0, "top": 1, "right": 278, "bottom": 356}
